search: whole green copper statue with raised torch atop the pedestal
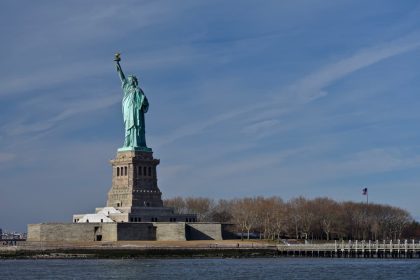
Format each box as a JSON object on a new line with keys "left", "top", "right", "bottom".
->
{"left": 114, "top": 53, "right": 151, "bottom": 151}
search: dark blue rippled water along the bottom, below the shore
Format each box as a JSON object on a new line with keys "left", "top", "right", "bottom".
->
{"left": 0, "top": 258, "right": 420, "bottom": 280}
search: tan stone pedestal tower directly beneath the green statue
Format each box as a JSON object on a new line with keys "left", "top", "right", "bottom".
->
{"left": 104, "top": 149, "right": 197, "bottom": 222}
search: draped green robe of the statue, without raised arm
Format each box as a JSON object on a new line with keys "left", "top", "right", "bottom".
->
{"left": 122, "top": 81, "right": 149, "bottom": 147}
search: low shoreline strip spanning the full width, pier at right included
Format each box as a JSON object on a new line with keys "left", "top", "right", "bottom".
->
{"left": 0, "top": 240, "right": 420, "bottom": 259}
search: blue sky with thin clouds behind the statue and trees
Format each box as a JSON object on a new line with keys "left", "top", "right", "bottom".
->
{"left": 0, "top": 0, "right": 420, "bottom": 230}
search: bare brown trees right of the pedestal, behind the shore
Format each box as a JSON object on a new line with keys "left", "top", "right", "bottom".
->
{"left": 164, "top": 196, "right": 420, "bottom": 240}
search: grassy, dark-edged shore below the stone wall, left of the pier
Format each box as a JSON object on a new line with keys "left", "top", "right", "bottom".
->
{"left": 0, "top": 240, "right": 278, "bottom": 259}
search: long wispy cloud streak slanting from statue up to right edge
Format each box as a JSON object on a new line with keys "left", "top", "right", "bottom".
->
{"left": 155, "top": 33, "right": 420, "bottom": 145}
